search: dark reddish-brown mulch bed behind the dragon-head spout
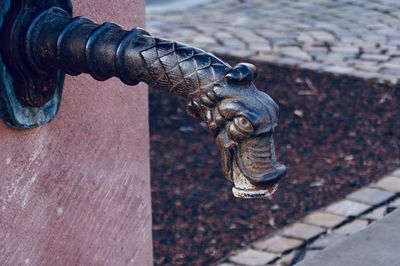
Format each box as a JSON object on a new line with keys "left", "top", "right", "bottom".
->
{"left": 150, "top": 60, "right": 400, "bottom": 265}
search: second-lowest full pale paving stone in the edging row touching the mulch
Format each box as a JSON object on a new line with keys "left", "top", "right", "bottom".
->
{"left": 253, "top": 235, "right": 303, "bottom": 253}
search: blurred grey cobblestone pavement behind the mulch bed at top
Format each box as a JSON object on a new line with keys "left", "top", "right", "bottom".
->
{"left": 147, "top": 0, "right": 400, "bottom": 83}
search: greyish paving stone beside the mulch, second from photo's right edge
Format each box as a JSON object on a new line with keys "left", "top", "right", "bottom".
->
{"left": 347, "top": 187, "right": 395, "bottom": 206}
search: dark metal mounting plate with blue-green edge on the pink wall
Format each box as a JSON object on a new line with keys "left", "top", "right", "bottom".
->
{"left": 0, "top": 0, "right": 72, "bottom": 128}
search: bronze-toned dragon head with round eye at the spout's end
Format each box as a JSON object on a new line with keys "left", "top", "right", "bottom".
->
{"left": 187, "top": 63, "right": 286, "bottom": 198}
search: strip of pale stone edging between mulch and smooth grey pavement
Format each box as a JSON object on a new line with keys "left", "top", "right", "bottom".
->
{"left": 219, "top": 168, "right": 400, "bottom": 266}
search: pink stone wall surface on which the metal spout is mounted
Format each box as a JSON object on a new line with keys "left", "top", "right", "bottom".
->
{"left": 0, "top": 0, "right": 152, "bottom": 265}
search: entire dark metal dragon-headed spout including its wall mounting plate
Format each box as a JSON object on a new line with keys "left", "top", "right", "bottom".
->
{"left": 0, "top": 0, "right": 286, "bottom": 198}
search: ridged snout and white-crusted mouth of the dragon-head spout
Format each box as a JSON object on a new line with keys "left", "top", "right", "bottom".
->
{"left": 217, "top": 134, "right": 286, "bottom": 198}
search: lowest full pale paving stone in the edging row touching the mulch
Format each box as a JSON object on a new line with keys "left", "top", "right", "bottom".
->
{"left": 229, "top": 249, "right": 278, "bottom": 266}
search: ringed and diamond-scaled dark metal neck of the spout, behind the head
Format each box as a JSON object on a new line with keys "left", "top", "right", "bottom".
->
{"left": 26, "top": 8, "right": 231, "bottom": 96}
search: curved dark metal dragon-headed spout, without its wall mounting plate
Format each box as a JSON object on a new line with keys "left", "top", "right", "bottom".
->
{"left": 1, "top": 4, "right": 286, "bottom": 198}
